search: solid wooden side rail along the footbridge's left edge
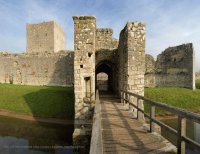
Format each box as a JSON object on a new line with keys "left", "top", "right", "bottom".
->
{"left": 90, "top": 90, "right": 103, "bottom": 154}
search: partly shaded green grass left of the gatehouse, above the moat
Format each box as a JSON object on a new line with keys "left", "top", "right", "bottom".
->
{"left": 0, "top": 84, "right": 74, "bottom": 119}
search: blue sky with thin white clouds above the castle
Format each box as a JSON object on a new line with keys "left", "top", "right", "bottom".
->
{"left": 0, "top": 0, "right": 200, "bottom": 71}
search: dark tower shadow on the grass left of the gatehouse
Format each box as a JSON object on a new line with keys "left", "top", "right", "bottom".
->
{"left": 23, "top": 87, "right": 74, "bottom": 120}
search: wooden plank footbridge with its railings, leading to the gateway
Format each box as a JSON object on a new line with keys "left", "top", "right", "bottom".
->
{"left": 90, "top": 92, "right": 200, "bottom": 154}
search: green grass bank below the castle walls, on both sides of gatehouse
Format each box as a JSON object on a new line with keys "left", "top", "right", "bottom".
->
{"left": 0, "top": 80, "right": 200, "bottom": 119}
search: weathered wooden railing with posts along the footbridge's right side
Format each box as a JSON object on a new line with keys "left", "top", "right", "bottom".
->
{"left": 121, "top": 90, "right": 200, "bottom": 153}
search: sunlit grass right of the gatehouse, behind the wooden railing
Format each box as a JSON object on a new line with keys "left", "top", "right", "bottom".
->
{"left": 145, "top": 80, "right": 200, "bottom": 116}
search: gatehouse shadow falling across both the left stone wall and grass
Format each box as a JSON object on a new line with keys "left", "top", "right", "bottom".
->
{"left": 20, "top": 52, "right": 74, "bottom": 120}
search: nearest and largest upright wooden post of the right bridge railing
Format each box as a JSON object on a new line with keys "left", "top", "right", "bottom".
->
{"left": 177, "top": 115, "right": 186, "bottom": 154}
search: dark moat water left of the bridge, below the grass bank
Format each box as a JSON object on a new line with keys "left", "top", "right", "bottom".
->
{"left": 0, "top": 116, "right": 76, "bottom": 154}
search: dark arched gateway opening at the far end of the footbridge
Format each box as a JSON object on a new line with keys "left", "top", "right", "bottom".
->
{"left": 95, "top": 61, "right": 114, "bottom": 92}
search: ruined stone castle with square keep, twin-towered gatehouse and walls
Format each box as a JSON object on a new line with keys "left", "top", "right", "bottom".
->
{"left": 0, "top": 16, "right": 195, "bottom": 119}
